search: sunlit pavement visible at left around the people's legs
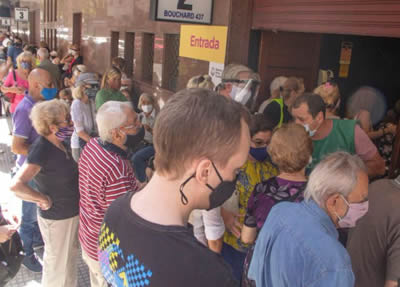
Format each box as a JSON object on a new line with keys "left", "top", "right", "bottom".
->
{"left": 0, "top": 117, "right": 90, "bottom": 287}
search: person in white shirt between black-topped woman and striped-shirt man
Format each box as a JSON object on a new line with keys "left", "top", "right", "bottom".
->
{"left": 71, "top": 85, "right": 94, "bottom": 162}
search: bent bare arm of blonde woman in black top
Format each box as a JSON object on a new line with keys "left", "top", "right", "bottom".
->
{"left": 10, "top": 163, "right": 51, "bottom": 210}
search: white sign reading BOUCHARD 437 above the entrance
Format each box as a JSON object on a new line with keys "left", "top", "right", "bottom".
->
{"left": 150, "top": 0, "right": 214, "bottom": 24}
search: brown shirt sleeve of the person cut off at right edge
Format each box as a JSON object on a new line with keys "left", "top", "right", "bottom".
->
{"left": 386, "top": 225, "right": 400, "bottom": 281}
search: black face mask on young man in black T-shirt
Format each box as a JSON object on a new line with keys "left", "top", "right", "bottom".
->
{"left": 179, "top": 162, "right": 237, "bottom": 210}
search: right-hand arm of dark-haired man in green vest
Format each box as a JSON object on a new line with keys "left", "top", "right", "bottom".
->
{"left": 354, "top": 125, "right": 385, "bottom": 177}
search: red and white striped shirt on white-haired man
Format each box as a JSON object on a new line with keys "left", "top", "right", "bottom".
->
{"left": 79, "top": 138, "right": 138, "bottom": 261}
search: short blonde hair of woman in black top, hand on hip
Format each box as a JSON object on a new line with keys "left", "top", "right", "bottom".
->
{"left": 30, "top": 99, "right": 69, "bottom": 136}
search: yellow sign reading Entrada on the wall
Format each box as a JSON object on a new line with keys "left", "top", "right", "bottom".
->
{"left": 179, "top": 25, "right": 228, "bottom": 63}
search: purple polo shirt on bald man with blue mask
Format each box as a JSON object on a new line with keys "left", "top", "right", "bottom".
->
{"left": 13, "top": 93, "right": 39, "bottom": 167}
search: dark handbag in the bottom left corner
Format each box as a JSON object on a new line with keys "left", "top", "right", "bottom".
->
{"left": 0, "top": 212, "right": 25, "bottom": 286}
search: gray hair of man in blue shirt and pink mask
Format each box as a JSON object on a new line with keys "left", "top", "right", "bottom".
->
{"left": 304, "top": 151, "right": 367, "bottom": 207}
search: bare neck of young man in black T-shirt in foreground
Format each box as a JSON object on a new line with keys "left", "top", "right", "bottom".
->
{"left": 131, "top": 172, "right": 193, "bottom": 226}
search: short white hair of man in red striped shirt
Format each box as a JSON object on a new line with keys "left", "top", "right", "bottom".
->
{"left": 96, "top": 101, "right": 133, "bottom": 142}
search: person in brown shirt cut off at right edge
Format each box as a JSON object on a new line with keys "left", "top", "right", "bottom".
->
{"left": 347, "top": 176, "right": 400, "bottom": 287}
